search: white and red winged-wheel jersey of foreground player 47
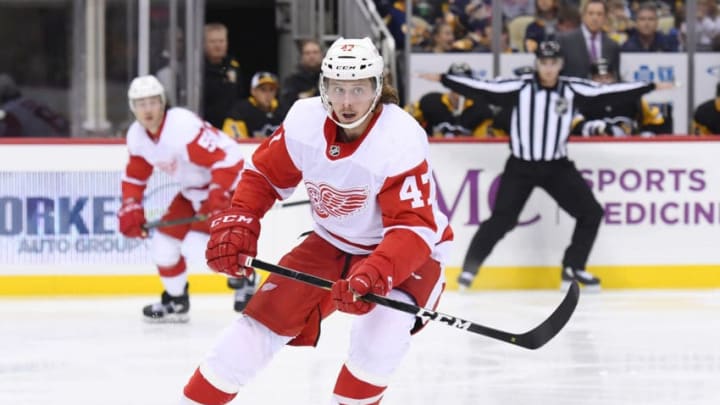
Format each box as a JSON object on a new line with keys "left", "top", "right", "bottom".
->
{"left": 247, "top": 97, "right": 452, "bottom": 262}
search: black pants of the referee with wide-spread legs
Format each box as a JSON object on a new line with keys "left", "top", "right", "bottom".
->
{"left": 462, "top": 156, "right": 603, "bottom": 274}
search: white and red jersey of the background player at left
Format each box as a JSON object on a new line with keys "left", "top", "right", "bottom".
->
{"left": 123, "top": 108, "right": 244, "bottom": 202}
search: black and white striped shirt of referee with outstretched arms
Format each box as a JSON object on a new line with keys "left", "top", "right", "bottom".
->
{"left": 442, "top": 74, "right": 655, "bottom": 161}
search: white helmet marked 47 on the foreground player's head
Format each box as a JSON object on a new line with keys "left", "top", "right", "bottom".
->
{"left": 318, "top": 37, "right": 385, "bottom": 129}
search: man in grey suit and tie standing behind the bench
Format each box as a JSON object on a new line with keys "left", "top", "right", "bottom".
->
{"left": 558, "top": 0, "right": 620, "bottom": 79}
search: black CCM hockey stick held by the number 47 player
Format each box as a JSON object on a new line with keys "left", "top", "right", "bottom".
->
{"left": 239, "top": 255, "right": 580, "bottom": 349}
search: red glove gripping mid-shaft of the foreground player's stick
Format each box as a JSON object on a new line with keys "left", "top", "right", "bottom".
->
{"left": 332, "top": 256, "right": 392, "bottom": 315}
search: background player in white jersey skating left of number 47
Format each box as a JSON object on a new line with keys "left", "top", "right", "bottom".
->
{"left": 118, "top": 76, "right": 254, "bottom": 322}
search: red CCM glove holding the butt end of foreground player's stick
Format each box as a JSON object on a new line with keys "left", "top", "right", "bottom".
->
{"left": 205, "top": 207, "right": 260, "bottom": 277}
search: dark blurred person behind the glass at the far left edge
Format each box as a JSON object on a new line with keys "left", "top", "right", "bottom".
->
{"left": 0, "top": 73, "right": 70, "bottom": 137}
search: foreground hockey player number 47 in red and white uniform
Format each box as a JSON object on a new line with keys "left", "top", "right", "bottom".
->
{"left": 184, "top": 38, "right": 452, "bottom": 405}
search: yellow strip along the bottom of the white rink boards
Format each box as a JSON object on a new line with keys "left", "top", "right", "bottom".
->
{"left": 0, "top": 265, "right": 720, "bottom": 296}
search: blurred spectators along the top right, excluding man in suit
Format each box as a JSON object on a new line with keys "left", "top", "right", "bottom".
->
{"left": 375, "top": 0, "right": 720, "bottom": 52}
